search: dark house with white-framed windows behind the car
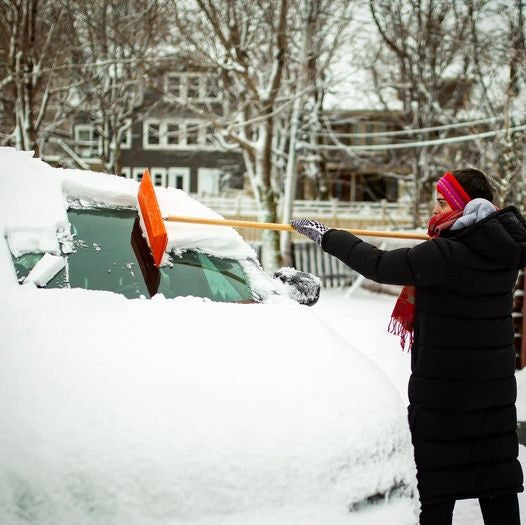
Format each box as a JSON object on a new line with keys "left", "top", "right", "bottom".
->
{"left": 65, "top": 67, "right": 245, "bottom": 195}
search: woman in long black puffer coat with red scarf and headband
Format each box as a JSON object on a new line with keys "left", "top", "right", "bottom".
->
{"left": 292, "top": 169, "right": 526, "bottom": 525}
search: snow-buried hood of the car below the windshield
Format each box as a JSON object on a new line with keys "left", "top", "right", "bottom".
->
{"left": 0, "top": 278, "right": 414, "bottom": 525}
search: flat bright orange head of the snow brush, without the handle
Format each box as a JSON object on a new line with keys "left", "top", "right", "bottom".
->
{"left": 137, "top": 170, "right": 168, "bottom": 267}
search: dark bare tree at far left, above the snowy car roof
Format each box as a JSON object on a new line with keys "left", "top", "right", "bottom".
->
{"left": 0, "top": 0, "right": 78, "bottom": 156}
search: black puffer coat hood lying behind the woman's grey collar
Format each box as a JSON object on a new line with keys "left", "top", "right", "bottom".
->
{"left": 445, "top": 206, "right": 526, "bottom": 268}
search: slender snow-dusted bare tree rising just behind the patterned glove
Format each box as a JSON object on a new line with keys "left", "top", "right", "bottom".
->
{"left": 279, "top": 0, "right": 354, "bottom": 266}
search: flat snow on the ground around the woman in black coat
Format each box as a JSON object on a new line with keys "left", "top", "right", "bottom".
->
{"left": 312, "top": 289, "right": 526, "bottom": 525}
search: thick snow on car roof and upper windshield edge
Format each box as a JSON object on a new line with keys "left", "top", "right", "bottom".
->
{"left": 0, "top": 147, "right": 255, "bottom": 259}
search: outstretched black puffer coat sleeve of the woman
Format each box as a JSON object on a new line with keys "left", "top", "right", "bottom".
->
{"left": 321, "top": 230, "right": 451, "bottom": 286}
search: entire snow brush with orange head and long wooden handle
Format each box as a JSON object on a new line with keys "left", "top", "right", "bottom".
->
{"left": 137, "top": 170, "right": 429, "bottom": 267}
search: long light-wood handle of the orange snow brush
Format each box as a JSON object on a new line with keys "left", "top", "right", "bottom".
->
{"left": 163, "top": 215, "right": 429, "bottom": 241}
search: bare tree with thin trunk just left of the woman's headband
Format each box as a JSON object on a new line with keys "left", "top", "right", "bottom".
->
{"left": 369, "top": 0, "right": 472, "bottom": 226}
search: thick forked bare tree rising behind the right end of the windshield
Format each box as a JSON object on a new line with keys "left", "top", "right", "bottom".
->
{"left": 168, "top": 0, "right": 292, "bottom": 269}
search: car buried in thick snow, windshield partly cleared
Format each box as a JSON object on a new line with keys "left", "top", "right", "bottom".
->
{"left": 0, "top": 148, "right": 415, "bottom": 525}
